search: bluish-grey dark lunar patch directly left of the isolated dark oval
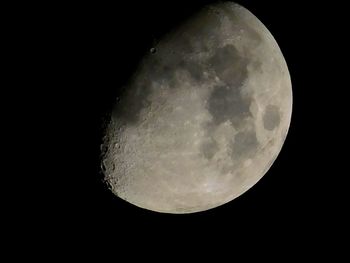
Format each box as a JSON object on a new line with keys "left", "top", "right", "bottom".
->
{"left": 207, "top": 86, "right": 252, "bottom": 128}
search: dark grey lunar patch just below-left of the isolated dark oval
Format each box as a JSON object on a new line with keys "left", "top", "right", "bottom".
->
{"left": 231, "top": 131, "right": 259, "bottom": 158}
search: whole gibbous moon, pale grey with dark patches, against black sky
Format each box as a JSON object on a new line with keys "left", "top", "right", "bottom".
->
{"left": 102, "top": 2, "right": 292, "bottom": 214}
